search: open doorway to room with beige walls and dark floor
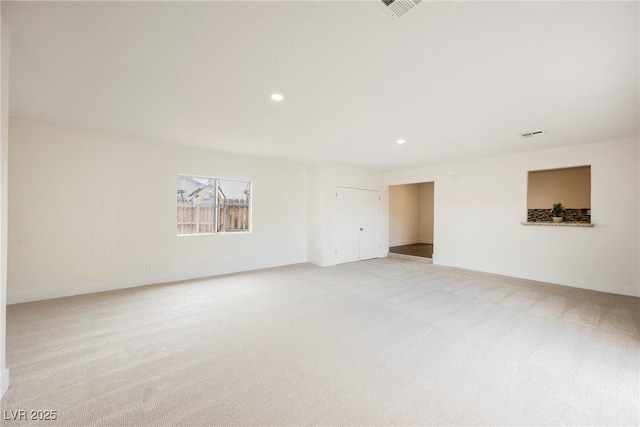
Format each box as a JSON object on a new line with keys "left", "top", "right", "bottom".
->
{"left": 389, "top": 182, "right": 434, "bottom": 259}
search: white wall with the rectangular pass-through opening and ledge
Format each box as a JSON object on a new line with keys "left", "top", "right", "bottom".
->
{"left": 385, "top": 139, "right": 640, "bottom": 296}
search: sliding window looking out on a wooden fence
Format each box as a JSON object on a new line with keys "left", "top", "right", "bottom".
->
{"left": 177, "top": 175, "right": 251, "bottom": 235}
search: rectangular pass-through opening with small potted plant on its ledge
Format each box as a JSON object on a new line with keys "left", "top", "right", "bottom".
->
{"left": 527, "top": 166, "right": 591, "bottom": 223}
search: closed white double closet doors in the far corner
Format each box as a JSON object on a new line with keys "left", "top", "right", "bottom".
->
{"left": 334, "top": 187, "right": 380, "bottom": 264}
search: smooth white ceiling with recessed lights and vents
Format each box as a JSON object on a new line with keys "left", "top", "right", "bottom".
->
{"left": 2, "top": 0, "right": 640, "bottom": 170}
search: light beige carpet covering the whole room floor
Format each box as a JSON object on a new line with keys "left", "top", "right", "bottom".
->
{"left": 2, "top": 258, "right": 640, "bottom": 426}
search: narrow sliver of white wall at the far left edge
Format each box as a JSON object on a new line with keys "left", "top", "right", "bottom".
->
{"left": 0, "top": 17, "right": 11, "bottom": 398}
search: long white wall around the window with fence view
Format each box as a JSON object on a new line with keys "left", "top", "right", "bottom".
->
{"left": 8, "top": 119, "right": 308, "bottom": 303}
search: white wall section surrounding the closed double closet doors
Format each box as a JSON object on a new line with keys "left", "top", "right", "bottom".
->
{"left": 308, "top": 163, "right": 389, "bottom": 266}
